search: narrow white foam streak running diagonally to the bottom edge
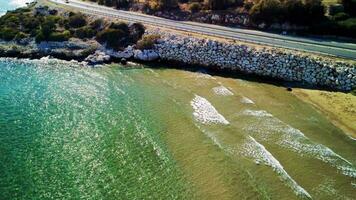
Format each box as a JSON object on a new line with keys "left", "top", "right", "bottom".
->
{"left": 243, "top": 136, "right": 311, "bottom": 199}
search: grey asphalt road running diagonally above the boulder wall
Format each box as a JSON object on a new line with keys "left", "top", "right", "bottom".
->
{"left": 48, "top": 0, "right": 356, "bottom": 60}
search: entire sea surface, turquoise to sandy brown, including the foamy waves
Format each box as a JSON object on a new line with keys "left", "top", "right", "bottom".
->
{"left": 0, "top": 59, "right": 356, "bottom": 199}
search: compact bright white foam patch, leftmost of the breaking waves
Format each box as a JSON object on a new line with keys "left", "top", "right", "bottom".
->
{"left": 190, "top": 95, "right": 229, "bottom": 124}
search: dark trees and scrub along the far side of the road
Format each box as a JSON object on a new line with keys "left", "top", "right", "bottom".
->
{"left": 86, "top": 0, "right": 356, "bottom": 38}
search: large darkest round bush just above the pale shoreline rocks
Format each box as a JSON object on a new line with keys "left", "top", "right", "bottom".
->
{"left": 96, "top": 28, "right": 128, "bottom": 49}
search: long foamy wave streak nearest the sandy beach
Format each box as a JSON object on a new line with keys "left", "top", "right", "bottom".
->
{"left": 243, "top": 110, "right": 356, "bottom": 177}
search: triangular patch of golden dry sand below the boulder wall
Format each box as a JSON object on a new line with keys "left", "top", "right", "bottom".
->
{"left": 293, "top": 89, "right": 356, "bottom": 139}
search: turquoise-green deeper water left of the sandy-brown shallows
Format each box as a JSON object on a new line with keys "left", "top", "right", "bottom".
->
{"left": 0, "top": 60, "right": 193, "bottom": 199}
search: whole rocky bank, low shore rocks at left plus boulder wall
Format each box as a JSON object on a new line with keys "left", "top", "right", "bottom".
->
{"left": 0, "top": 17, "right": 356, "bottom": 91}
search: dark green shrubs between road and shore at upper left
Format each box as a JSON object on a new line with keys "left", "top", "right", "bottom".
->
{"left": 0, "top": 7, "right": 145, "bottom": 49}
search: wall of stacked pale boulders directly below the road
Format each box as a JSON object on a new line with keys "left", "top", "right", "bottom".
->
{"left": 154, "top": 31, "right": 356, "bottom": 91}
